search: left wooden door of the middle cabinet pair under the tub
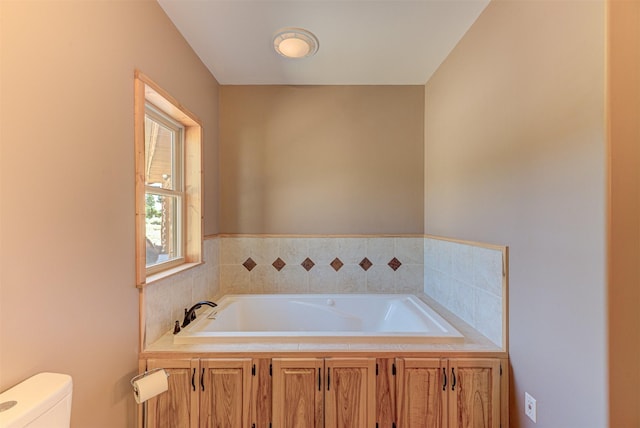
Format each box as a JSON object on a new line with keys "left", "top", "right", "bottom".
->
{"left": 272, "top": 358, "right": 324, "bottom": 428}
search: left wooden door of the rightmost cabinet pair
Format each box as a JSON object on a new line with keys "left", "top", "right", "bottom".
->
{"left": 396, "top": 358, "right": 448, "bottom": 428}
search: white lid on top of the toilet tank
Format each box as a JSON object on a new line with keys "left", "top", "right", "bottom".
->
{"left": 0, "top": 372, "right": 73, "bottom": 427}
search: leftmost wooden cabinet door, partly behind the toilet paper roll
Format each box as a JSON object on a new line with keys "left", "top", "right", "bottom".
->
{"left": 145, "top": 359, "right": 198, "bottom": 428}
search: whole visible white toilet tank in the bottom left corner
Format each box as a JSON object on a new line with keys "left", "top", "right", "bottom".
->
{"left": 0, "top": 373, "right": 72, "bottom": 428}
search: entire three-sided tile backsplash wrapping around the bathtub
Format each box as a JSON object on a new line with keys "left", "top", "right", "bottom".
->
{"left": 143, "top": 235, "right": 506, "bottom": 346}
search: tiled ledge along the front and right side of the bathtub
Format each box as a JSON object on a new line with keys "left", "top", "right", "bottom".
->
{"left": 140, "top": 294, "right": 508, "bottom": 359}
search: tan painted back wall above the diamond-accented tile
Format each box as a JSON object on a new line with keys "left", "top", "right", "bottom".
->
{"left": 220, "top": 86, "right": 424, "bottom": 234}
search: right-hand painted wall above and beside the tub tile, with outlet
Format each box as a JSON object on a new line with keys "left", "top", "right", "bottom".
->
{"left": 425, "top": 1, "right": 607, "bottom": 428}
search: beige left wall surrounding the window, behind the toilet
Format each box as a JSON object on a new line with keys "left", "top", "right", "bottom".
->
{"left": 0, "top": 0, "right": 218, "bottom": 428}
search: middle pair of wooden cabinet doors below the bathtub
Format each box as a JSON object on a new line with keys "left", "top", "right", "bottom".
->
{"left": 273, "top": 358, "right": 376, "bottom": 428}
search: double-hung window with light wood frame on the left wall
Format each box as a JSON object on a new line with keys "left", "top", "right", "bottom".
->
{"left": 135, "top": 72, "right": 202, "bottom": 286}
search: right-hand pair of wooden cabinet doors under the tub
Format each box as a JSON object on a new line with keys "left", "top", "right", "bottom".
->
{"left": 396, "top": 358, "right": 502, "bottom": 428}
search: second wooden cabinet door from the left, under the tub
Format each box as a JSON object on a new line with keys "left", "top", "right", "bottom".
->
{"left": 199, "top": 358, "right": 251, "bottom": 428}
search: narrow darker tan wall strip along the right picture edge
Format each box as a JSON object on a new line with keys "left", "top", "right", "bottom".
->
{"left": 607, "top": 0, "right": 640, "bottom": 427}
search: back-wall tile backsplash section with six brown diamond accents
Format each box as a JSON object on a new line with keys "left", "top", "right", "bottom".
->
{"left": 220, "top": 237, "right": 424, "bottom": 294}
